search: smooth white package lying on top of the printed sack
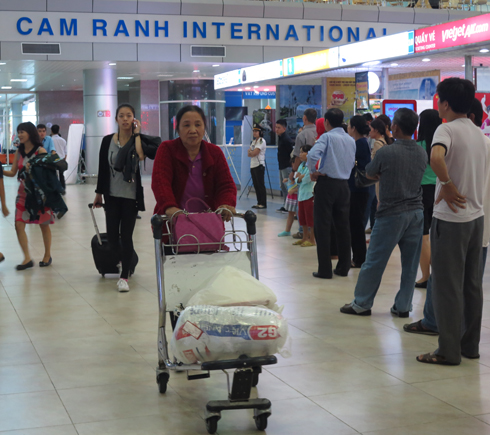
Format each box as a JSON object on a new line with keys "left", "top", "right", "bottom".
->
{"left": 187, "top": 266, "right": 281, "bottom": 311}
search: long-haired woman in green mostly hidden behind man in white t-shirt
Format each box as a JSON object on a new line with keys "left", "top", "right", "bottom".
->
{"left": 415, "top": 109, "right": 442, "bottom": 288}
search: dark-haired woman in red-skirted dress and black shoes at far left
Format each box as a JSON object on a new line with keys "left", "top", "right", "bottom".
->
{"left": 3, "top": 122, "right": 54, "bottom": 270}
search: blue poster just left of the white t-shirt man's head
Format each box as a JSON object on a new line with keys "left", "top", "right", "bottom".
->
{"left": 388, "top": 70, "right": 441, "bottom": 100}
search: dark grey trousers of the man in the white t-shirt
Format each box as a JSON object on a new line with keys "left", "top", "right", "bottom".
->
{"left": 430, "top": 217, "right": 483, "bottom": 363}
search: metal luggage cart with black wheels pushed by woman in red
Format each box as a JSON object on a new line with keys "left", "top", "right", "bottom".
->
{"left": 151, "top": 211, "right": 277, "bottom": 434}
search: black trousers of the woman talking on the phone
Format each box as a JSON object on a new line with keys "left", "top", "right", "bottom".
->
{"left": 104, "top": 196, "right": 138, "bottom": 279}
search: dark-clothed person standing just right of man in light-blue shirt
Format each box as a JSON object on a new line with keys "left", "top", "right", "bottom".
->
{"left": 347, "top": 115, "right": 371, "bottom": 268}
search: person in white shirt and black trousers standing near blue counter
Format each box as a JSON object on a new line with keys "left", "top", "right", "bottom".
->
{"left": 247, "top": 124, "right": 267, "bottom": 209}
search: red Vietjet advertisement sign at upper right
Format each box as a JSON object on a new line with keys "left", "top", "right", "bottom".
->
{"left": 415, "top": 14, "right": 490, "bottom": 53}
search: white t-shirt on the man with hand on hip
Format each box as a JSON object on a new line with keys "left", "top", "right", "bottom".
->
{"left": 432, "top": 118, "right": 490, "bottom": 223}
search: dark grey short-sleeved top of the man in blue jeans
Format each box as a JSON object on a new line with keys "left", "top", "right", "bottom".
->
{"left": 366, "top": 140, "right": 427, "bottom": 217}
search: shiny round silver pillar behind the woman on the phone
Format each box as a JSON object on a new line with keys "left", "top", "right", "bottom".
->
{"left": 83, "top": 69, "right": 117, "bottom": 181}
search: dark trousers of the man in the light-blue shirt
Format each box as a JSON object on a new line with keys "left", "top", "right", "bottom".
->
{"left": 314, "top": 176, "right": 351, "bottom": 277}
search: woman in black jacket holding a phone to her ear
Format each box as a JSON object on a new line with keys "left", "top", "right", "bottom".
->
{"left": 94, "top": 103, "right": 146, "bottom": 292}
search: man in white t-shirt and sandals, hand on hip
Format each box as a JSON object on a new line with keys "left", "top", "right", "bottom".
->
{"left": 417, "top": 78, "right": 489, "bottom": 365}
